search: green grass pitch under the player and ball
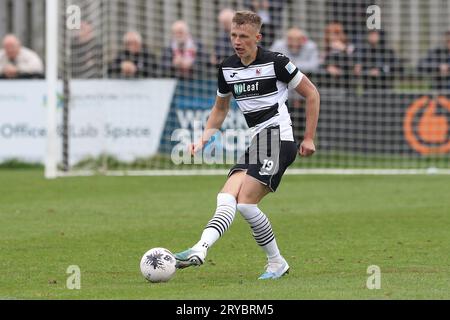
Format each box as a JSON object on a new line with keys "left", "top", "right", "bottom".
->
{"left": 0, "top": 170, "right": 450, "bottom": 299}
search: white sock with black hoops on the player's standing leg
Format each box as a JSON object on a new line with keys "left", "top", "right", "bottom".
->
{"left": 237, "top": 204, "right": 281, "bottom": 261}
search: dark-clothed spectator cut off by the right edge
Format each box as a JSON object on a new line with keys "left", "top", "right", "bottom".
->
{"left": 418, "top": 30, "right": 450, "bottom": 90}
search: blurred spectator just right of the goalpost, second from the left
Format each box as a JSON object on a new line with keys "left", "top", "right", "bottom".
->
{"left": 71, "top": 21, "right": 102, "bottom": 79}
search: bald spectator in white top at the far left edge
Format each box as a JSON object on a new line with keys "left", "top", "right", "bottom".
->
{"left": 0, "top": 34, "right": 44, "bottom": 79}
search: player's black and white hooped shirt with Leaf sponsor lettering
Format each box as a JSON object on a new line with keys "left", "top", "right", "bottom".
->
{"left": 217, "top": 47, "right": 303, "bottom": 141}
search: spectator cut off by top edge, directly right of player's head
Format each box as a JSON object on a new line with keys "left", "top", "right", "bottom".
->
{"left": 244, "top": 0, "right": 285, "bottom": 48}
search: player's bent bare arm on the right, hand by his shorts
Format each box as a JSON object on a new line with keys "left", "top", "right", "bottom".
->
{"left": 295, "top": 76, "right": 320, "bottom": 157}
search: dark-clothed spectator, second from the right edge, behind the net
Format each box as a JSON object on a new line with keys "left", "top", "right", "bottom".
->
{"left": 354, "top": 30, "right": 399, "bottom": 89}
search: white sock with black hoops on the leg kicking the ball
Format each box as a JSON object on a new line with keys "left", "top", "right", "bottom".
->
{"left": 192, "top": 193, "right": 236, "bottom": 250}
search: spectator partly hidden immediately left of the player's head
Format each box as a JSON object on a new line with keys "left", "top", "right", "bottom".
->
{"left": 211, "top": 8, "right": 235, "bottom": 66}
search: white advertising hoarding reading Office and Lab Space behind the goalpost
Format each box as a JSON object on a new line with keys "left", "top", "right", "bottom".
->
{"left": 0, "top": 79, "right": 176, "bottom": 164}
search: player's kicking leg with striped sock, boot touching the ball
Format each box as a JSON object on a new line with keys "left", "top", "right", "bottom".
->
{"left": 175, "top": 171, "right": 246, "bottom": 269}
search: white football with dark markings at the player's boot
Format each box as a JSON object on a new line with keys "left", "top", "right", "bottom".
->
{"left": 141, "top": 248, "right": 176, "bottom": 282}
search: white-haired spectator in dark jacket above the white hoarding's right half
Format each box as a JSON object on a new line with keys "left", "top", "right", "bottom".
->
{"left": 108, "top": 31, "right": 157, "bottom": 78}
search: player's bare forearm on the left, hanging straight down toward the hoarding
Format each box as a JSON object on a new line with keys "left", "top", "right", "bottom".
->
{"left": 189, "top": 95, "right": 231, "bottom": 155}
